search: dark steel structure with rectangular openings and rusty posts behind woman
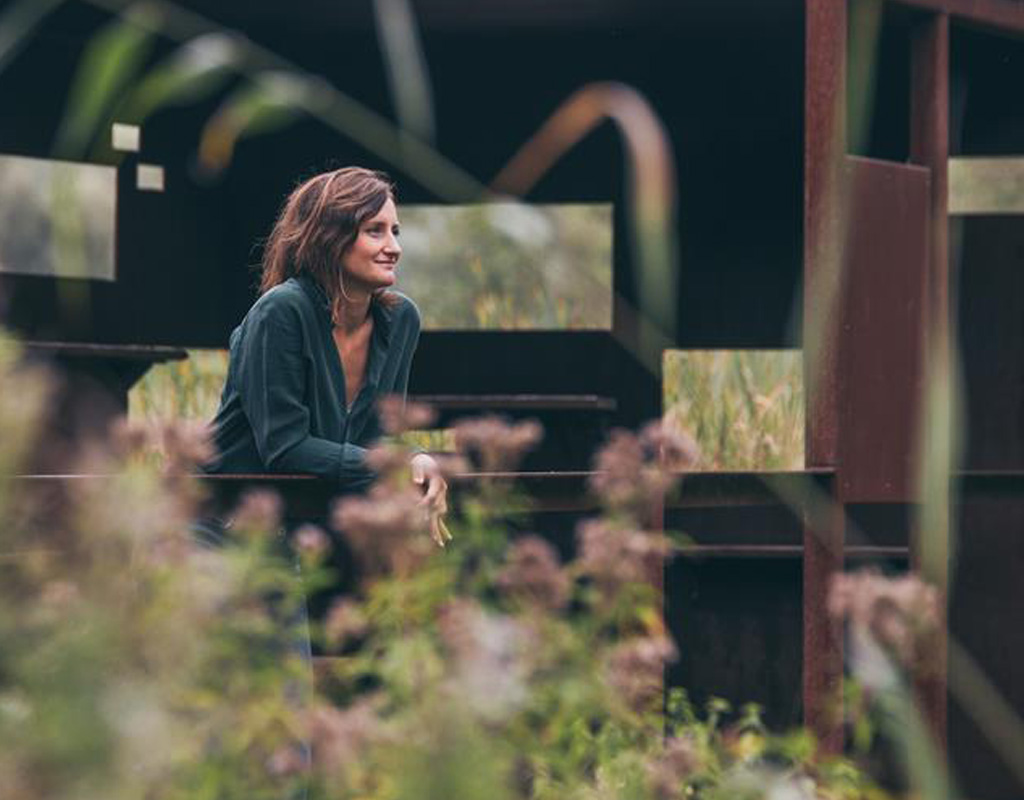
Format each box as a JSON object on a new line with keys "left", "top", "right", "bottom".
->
{"left": 0, "top": 0, "right": 1024, "bottom": 798}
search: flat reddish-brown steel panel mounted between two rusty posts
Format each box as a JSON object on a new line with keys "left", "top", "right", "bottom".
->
{"left": 838, "top": 158, "right": 931, "bottom": 503}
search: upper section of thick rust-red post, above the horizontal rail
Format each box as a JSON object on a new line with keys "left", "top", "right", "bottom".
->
{"left": 804, "top": 0, "right": 847, "bottom": 467}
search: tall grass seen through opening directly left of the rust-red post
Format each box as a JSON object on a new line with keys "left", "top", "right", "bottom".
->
{"left": 663, "top": 350, "right": 804, "bottom": 471}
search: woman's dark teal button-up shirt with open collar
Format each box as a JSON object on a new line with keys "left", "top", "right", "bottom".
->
{"left": 207, "top": 276, "right": 420, "bottom": 488}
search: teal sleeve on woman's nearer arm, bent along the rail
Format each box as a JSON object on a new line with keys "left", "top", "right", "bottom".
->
{"left": 239, "top": 303, "right": 374, "bottom": 485}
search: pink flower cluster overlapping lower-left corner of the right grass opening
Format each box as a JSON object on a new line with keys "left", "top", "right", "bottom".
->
{"left": 590, "top": 422, "right": 698, "bottom": 519}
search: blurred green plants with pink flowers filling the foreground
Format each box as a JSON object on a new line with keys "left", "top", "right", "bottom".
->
{"left": 0, "top": 329, "right": 888, "bottom": 800}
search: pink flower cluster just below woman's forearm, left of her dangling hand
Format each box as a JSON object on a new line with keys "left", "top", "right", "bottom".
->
{"left": 332, "top": 485, "right": 431, "bottom": 575}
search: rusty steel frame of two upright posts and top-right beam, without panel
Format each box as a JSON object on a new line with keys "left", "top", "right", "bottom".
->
{"left": 804, "top": 0, "right": 954, "bottom": 750}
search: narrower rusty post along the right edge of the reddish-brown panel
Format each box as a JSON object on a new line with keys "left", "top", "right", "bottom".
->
{"left": 910, "top": 10, "right": 950, "bottom": 749}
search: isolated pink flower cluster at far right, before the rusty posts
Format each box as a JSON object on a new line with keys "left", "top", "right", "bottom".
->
{"left": 828, "top": 570, "right": 940, "bottom": 669}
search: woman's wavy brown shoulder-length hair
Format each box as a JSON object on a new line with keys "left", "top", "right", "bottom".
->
{"left": 259, "top": 167, "right": 398, "bottom": 320}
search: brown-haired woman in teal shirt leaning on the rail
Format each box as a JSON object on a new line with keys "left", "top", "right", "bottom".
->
{"left": 208, "top": 167, "right": 447, "bottom": 544}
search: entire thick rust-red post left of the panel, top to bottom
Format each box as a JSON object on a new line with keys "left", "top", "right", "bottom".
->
{"left": 803, "top": 0, "right": 847, "bottom": 753}
